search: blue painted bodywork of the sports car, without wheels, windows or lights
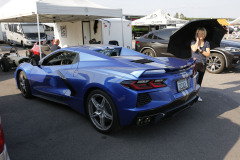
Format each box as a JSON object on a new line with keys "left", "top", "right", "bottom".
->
{"left": 15, "top": 45, "right": 200, "bottom": 125}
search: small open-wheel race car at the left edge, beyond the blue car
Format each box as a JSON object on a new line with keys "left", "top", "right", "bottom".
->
{"left": 0, "top": 47, "right": 30, "bottom": 72}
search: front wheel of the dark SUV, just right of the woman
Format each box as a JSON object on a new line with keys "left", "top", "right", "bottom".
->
{"left": 206, "top": 53, "right": 225, "bottom": 74}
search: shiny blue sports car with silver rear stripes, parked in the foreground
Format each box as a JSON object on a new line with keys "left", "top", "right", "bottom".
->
{"left": 15, "top": 44, "right": 200, "bottom": 133}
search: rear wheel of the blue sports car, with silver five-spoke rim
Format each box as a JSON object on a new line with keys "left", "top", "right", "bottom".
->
{"left": 86, "top": 90, "right": 119, "bottom": 134}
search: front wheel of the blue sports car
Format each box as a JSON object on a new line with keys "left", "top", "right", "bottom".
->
{"left": 18, "top": 71, "right": 32, "bottom": 98}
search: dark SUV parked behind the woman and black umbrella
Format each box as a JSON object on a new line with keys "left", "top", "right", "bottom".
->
{"left": 135, "top": 28, "right": 240, "bottom": 73}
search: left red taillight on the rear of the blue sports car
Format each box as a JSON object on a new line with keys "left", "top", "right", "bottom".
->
{"left": 121, "top": 79, "right": 167, "bottom": 90}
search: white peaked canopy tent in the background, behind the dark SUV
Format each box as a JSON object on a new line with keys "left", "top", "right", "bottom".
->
{"left": 132, "top": 9, "right": 188, "bottom": 26}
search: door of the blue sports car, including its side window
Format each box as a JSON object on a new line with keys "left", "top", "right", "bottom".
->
{"left": 30, "top": 51, "right": 79, "bottom": 101}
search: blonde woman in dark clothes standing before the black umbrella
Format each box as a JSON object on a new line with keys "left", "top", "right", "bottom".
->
{"left": 191, "top": 27, "right": 210, "bottom": 101}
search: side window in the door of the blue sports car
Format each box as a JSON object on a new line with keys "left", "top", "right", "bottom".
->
{"left": 42, "top": 51, "right": 78, "bottom": 66}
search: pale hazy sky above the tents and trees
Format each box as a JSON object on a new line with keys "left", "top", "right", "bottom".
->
{"left": 0, "top": 0, "right": 240, "bottom": 19}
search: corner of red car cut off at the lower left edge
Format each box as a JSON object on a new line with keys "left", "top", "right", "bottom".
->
{"left": 0, "top": 117, "right": 10, "bottom": 160}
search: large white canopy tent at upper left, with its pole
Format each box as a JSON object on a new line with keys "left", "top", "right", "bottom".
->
{"left": 0, "top": 0, "right": 122, "bottom": 58}
